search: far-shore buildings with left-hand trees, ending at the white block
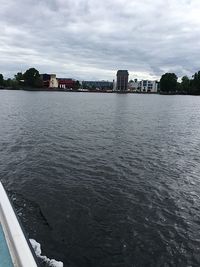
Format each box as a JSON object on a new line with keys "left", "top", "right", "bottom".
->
{"left": 0, "top": 68, "right": 159, "bottom": 93}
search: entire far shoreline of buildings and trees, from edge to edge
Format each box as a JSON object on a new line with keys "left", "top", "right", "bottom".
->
{"left": 0, "top": 68, "right": 200, "bottom": 95}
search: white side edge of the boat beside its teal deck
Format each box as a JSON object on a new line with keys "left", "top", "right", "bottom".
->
{"left": 0, "top": 182, "right": 38, "bottom": 267}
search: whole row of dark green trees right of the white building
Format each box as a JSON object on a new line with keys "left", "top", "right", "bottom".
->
{"left": 160, "top": 71, "right": 200, "bottom": 95}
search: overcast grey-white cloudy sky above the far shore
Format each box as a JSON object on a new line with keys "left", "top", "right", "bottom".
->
{"left": 0, "top": 0, "right": 200, "bottom": 80}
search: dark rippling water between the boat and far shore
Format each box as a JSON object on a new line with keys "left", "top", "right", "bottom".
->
{"left": 0, "top": 91, "right": 200, "bottom": 267}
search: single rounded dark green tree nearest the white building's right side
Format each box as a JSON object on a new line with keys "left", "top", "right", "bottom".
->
{"left": 160, "top": 73, "right": 178, "bottom": 93}
